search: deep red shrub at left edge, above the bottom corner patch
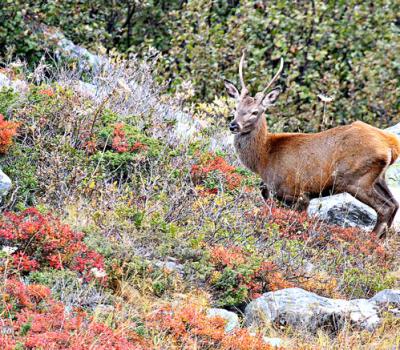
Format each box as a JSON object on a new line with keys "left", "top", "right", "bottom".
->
{"left": 0, "top": 208, "right": 104, "bottom": 279}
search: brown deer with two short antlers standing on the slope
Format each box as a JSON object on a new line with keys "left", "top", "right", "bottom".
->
{"left": 224, "top": 52, "right": 400, "bottom": 238}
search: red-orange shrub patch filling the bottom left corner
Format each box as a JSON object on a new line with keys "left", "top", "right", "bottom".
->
{"left": 0, "top": 279, "right": 150, "bottom": 350}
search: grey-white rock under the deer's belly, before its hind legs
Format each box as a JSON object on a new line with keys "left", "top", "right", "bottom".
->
{"left": 307, "top": 193, "right": 376, "bottom": 230}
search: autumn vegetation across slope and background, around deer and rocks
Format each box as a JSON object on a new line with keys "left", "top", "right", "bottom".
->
{"left": 0, "top": 0, "right": 400, "bottom": 350}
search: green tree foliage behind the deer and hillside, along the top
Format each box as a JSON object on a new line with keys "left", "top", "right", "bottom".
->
{"left": 0, "top": 0, "right": 400, "bottom": 131}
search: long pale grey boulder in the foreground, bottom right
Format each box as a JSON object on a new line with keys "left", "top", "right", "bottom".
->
{"left": 245, "top": 288, "right": 380, "bottom": 333}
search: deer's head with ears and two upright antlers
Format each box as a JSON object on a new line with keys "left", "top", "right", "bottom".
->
{"left": 225, "top": 52, "right": 283, "bottom": 134}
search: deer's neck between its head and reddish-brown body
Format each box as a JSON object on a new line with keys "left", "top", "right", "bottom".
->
{"left": 234, "top": 113, "right": 269, "bottom": 173}
